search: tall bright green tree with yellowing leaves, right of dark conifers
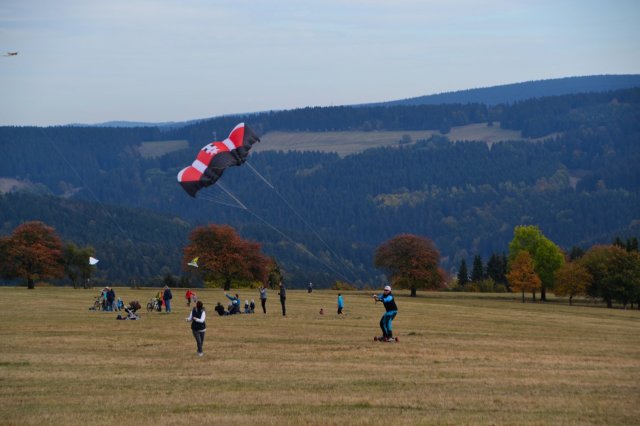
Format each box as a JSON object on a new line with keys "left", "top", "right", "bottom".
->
{"left": 509, "top": 226, "right": 564, "bottom": 301}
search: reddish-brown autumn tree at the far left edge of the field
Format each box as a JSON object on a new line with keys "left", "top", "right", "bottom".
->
{"left": 1, "top": 222, "right": 64, "bottom": 289}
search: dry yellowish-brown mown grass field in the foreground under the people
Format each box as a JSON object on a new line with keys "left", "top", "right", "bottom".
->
{"left": 0, "top": 287, "right": 640, "bottom": 425}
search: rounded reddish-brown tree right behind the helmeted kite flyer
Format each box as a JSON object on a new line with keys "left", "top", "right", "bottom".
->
{"left": 374, "top": 234, "right": 443, "bottom": 297}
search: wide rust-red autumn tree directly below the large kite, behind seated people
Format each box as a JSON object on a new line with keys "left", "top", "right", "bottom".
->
{"left": 182, "top": 225, "right": 270, "bottom": 290}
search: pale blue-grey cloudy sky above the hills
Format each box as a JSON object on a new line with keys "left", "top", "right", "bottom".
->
{"left": 0, "top": 0, "right": 640, "bottom": 126}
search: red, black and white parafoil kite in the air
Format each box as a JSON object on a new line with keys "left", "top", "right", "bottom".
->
{"left": 178, "top": 123, "right": 260, "bottom": 197}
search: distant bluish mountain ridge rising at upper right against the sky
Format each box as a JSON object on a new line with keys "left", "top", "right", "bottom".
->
{"left": 359, "top": 74, "right": 640, "bottom": 106}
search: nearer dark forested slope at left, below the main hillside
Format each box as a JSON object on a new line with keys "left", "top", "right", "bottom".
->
{"left": 0, "top": 192, "right": 191, "bottom": 285}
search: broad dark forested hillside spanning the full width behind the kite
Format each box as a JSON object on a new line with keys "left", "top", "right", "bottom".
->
{"left": 0, "top": 89, "right": 640, "bottom": 286}
